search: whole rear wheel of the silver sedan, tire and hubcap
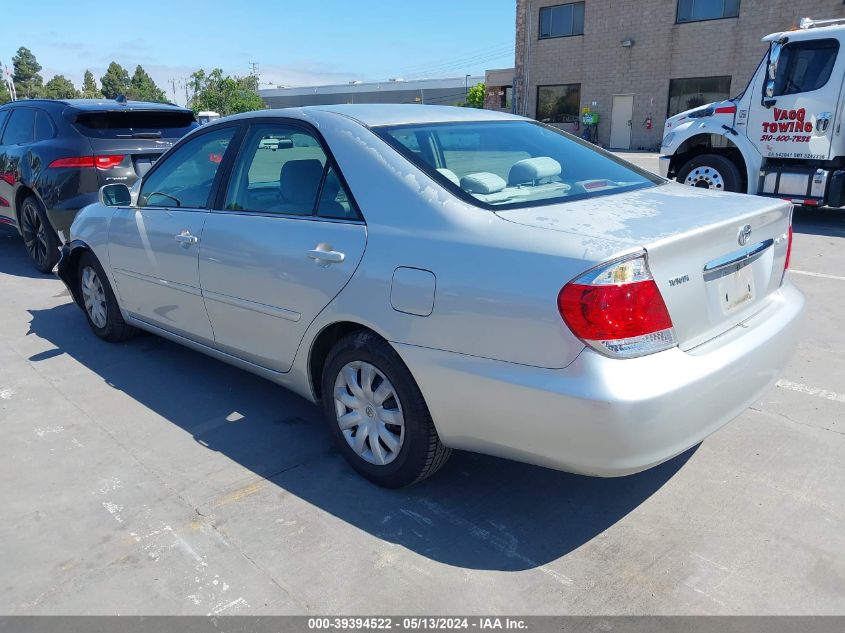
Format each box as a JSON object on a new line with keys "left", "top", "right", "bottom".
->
{"left": 322, "top": 332, "right": 451, "bottom": 488}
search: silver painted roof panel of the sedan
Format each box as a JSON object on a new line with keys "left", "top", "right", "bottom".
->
{"left": 224, "top": 103, "right": 525, "bottom": 127}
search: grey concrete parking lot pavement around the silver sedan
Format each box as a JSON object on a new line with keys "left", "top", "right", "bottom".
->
{"left": 0, "top": 155, "right": 845, "bottom": 615}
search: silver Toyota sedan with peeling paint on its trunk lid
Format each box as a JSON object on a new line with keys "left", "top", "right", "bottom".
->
{"left": 58, "top": 105, "right": 804, "bottom": 486}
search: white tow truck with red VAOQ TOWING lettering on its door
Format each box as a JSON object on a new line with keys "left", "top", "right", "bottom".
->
{"left": 660, "top": 18, "right": 845, "bottom": 207}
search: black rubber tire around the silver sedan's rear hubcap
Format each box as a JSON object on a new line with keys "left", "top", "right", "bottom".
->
{"left": 322, "top": 331, "right": 452, "bottom": 488}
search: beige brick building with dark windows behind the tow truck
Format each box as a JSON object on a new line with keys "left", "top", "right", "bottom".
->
{"left": 514, "top": 0, "right": 845, "bottom": 149}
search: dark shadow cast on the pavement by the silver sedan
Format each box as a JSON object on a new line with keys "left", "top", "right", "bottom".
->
{"left": 30, "top": 303, "right": 695, "bottom": 573}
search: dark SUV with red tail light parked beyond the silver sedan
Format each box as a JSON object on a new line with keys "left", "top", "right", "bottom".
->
{"left": 0, "top": 97, "right": 198, "bottom": 273}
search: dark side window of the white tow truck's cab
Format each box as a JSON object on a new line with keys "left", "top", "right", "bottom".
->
{"left": 773, "top": 39, "right": 839, "bottom": 97}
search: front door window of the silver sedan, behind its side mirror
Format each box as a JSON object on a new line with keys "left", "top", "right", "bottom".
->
{"left": 138, "top": 126, "right": 237, "bottom": 209}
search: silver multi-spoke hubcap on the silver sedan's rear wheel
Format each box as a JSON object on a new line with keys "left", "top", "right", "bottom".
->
{"left": 334, "top": 361, "right": 405, "bottom": 466}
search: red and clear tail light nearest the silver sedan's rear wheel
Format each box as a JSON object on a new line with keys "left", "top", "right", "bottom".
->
{"left": 557, "top": 254, "right": 677, "bottom": 358}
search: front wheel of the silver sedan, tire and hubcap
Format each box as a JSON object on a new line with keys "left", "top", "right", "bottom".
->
{"left": 76, "top": 251, "right": 136, "bottom": 343}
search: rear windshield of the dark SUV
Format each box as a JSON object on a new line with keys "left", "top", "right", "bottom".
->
{"left": 74, "top": 110, "right": 198, "bottom": 138}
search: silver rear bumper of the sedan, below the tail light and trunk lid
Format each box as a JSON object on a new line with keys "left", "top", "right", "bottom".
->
{"left": 396, "top": 281, "right": 804, "bottom": 477}
